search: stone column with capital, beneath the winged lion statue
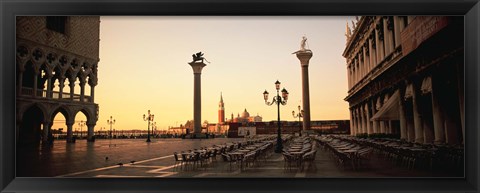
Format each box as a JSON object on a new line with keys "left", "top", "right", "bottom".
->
{"left": 188, "top": 61, "right": 207, "bottom": 136}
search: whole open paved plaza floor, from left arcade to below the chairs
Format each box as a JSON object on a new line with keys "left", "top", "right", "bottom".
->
{"left": 17, "top": 138, "right": 458, "bottom": 178}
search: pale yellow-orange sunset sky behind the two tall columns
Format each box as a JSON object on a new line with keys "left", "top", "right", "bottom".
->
{"left": 53, "top": 16, "right": 353, "bottom": 130}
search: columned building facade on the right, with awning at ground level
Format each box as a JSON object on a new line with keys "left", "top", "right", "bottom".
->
{"left": 343, "top": 16, "right": 465, "bottom": 144}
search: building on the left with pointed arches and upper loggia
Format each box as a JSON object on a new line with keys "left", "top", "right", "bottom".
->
{"left": 16, "top": 16, "right": 100, "bottom": 144}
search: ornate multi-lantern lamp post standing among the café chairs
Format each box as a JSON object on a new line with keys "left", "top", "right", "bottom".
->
{"left": 263, "top": 80, "right": 288, "bottom": 153}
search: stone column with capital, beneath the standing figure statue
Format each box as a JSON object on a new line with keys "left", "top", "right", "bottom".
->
{"left": 296, "top": 50, "right": 313, "bottom": 131}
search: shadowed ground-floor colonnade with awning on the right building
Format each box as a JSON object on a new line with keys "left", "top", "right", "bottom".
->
{"left": 350, "top": 74, "right": 465, "bottom": 144}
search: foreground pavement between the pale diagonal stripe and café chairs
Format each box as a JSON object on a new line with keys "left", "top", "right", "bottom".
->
{"left": 61, "top": 141, "right": 445, "bottom": 178}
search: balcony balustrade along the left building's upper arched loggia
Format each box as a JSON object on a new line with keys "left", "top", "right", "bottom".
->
{"left": 20, "top": 87, "right": 93, "bottom": 103}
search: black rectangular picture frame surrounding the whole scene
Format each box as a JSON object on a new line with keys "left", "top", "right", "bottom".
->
{"left": 0, "top": 0, "right": 480, "bottom": 193}
